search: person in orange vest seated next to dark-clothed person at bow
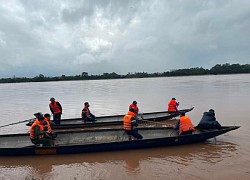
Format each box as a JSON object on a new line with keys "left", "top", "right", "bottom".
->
{"left": 175, "top": 112, "right": 195, "bottom": 135}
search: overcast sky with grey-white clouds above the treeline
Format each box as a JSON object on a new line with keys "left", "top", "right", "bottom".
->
{"left": 0, "top": 0, "right": 250, "bottom": 78}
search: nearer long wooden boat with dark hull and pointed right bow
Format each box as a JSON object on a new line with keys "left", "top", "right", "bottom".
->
{"left": 0, "top": 126, "right": 239, "bottom": 156}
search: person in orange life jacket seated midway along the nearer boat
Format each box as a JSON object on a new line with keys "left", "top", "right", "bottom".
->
{"left": 123, "top": 108, "right": 143, "bottom": 140}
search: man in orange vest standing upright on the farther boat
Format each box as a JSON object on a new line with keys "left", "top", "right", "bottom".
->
{"left": 49, "top": 97, "right": 62, "bottom": 124}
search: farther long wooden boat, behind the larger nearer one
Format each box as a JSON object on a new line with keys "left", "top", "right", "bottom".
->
{"left": 26, "top": 107, "right": 194, "bottom": 130}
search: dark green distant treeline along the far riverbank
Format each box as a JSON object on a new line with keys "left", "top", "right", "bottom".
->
{"left": 0, "top": 63, "right": 250, "bottom": 83}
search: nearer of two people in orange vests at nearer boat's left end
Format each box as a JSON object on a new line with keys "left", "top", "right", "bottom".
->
{"left": 30, "top": 115, "right": 52, "bottom": 146}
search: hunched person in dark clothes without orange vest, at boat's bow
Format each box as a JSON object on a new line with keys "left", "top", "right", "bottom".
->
{"left": 198, "top": 109, "right": 221, "bottom": 129}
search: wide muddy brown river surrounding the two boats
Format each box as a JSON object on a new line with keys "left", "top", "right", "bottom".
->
{"left": 0, "top": 74, "right": 250, "bottom": 180}
